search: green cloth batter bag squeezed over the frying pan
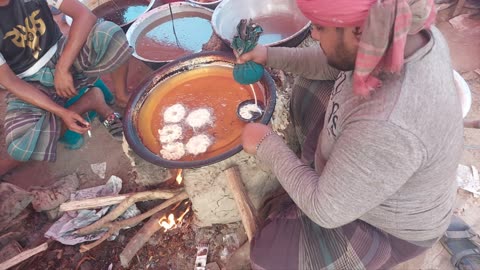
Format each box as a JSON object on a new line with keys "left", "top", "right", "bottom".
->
{"left": 232, "top": 19, "right": 264, "bottom": 84}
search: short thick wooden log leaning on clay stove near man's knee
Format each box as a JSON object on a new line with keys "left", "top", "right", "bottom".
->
{"left": 225, "top": 166, "right": 258, "bottom": 241}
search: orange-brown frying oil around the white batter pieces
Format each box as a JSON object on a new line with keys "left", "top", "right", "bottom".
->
{"left": 137, "top": 66, "right": 265, "bottom": 161}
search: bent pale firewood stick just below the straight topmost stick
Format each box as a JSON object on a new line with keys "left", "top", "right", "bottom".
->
{"left": 75, "top": 190, "right": 181, "bottom": 235}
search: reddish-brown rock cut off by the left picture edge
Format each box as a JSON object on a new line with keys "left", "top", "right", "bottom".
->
{"left": 0, "top": 183, "right": 33, "bottom": 231}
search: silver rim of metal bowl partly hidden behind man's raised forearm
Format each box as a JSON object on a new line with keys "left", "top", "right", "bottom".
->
{"left": 211, "top": 0, "right": 312, "bottom": 47}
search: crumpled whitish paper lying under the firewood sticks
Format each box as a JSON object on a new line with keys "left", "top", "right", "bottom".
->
{"left": 44, "top": 175, "right": 140, "bottom": 245}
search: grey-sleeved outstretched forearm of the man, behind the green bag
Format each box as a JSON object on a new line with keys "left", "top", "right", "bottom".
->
{"left": 266, "top": 46, "right": 340, "bottom": 81}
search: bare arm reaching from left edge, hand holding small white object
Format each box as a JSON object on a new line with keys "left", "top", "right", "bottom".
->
{"left": 0, "top": 63, "right": 90, "bottom": 133}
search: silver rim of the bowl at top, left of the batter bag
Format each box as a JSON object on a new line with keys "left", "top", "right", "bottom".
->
{"left": 125, "top": 2, "right": 213, "bottom": 69}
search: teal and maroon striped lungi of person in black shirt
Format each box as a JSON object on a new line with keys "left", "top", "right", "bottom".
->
{"left": 5, "top": 21, "right": 133, "bottom": 161}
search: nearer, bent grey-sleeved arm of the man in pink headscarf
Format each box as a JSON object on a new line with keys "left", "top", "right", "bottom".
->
{"left": 251, "top": 121, "right": 427, "bottom": 228}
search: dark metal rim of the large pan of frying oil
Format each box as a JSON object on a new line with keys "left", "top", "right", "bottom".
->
{"left": 123, "top": 52, "right": 276, "bottom": 168}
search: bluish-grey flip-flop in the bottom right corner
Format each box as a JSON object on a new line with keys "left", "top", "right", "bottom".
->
{"left": 440, "top": 216, "right": 480, "bottom": 270}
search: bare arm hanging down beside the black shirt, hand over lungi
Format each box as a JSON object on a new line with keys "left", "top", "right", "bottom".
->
{"left": 48, "top": 0, "right": 97, "bottom": 97}
